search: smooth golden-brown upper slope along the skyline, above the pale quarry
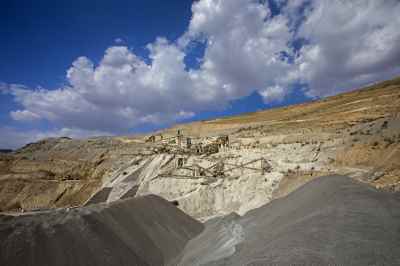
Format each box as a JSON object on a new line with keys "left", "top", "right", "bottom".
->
{"left": 162, "top": 77, "right": 400, "bottom": 135}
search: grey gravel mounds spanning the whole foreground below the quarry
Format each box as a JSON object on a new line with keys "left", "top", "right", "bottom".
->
{"left": 0, "top": 176, "right": 400, "bottom": 266}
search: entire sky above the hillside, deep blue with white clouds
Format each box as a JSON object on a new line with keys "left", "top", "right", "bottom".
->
{"left": 0, "top": 0, "right": 400, "bottom": 148}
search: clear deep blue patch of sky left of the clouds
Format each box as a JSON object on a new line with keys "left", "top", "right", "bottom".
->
{"left": 0, "top": 0, "right": 192, "bottom": 88}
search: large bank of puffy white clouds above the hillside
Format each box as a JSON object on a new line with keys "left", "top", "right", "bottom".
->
{"left": 0, "top": 0, "right": 400, "bottom": 148}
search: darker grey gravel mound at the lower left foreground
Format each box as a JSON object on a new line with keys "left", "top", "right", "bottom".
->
{"left": 0, "top": 196, "right": 203, "bottom": 266}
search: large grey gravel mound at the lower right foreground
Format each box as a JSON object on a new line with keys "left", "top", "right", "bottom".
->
{"left": 177, "top": 176, "right": 400, "bottom": 266}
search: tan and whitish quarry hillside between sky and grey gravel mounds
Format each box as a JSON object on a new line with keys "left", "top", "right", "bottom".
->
{"left": 0, "top": 75, "right": 400, "bottom": 221}
